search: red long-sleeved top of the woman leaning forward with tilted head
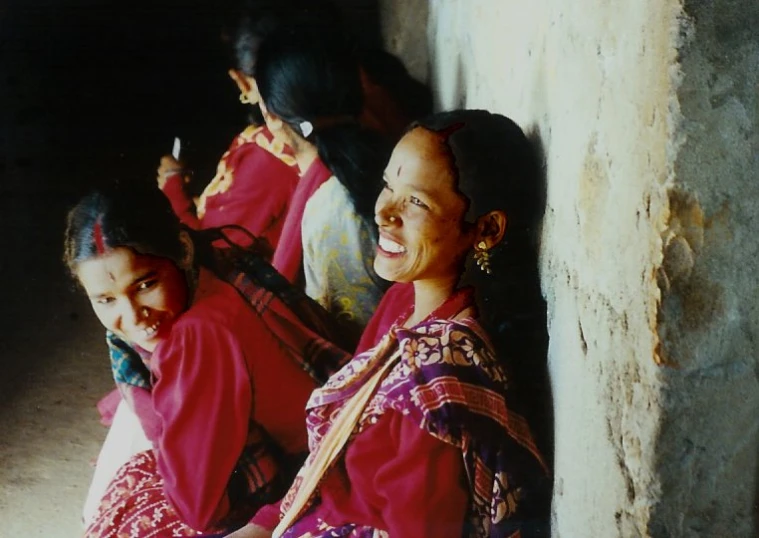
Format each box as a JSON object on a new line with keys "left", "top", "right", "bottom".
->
{"left": 148, "top": 269, "right": 314, "bottom": 529}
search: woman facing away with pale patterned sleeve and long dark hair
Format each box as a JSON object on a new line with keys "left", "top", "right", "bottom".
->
{"left": 255, "top": 29, "right": 390, "bottom": 339}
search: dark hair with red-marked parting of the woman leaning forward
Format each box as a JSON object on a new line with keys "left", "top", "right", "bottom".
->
{"left": 63, "top": 184, "right": 189, "bottom": 274}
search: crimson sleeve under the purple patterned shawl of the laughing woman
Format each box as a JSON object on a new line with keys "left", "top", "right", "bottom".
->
{"left": 346, "top": 411, "right": 469, "bottom": 538}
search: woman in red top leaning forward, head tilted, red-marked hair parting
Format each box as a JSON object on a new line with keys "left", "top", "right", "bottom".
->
{"left": 65, "top": 183, "right": 348, "bottom": 537}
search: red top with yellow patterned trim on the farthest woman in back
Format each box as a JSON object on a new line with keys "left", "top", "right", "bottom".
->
{"left": 163, "top": 127, "right": 298, "bottom": 249}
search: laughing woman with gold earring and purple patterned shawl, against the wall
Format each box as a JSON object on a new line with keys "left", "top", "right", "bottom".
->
{"left": 231, "top": 111, "right": 547, "bottom": 538}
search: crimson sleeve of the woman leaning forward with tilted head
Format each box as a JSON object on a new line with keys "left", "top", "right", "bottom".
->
{"left": 153, "top": 320, "right": 252, "bottom": 530}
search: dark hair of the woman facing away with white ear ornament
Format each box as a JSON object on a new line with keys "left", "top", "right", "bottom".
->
{"left": 255, "top": 29, "right": 392, "bottom": 222}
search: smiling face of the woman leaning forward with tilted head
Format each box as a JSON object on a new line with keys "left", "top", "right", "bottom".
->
{"left": 76, "top": 247, "right": 188, "bottom": 351}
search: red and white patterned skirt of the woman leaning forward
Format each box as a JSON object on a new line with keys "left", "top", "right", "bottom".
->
{"left": 85, "top": 450, "right": 214, "bottom": 538}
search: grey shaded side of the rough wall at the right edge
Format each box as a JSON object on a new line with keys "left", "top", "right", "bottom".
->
{"left": 652, "top": 0, "right": 759, "bottom": 537}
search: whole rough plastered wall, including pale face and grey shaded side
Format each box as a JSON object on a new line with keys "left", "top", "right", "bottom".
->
{"left": 383, "top": 0, "right": 759, "bottom": 538}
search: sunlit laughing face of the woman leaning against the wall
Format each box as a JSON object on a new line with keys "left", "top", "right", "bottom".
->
{"left": 374, "top": 127, "right": 474, "bottom": 282}
